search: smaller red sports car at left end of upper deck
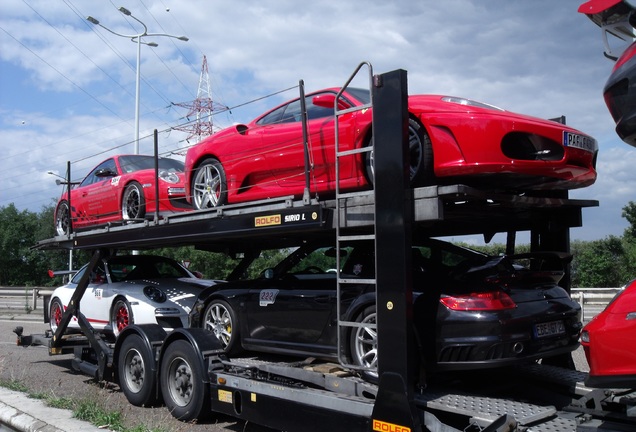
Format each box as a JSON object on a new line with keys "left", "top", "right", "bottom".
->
{"left": 55, "top": 155, "right": 191, "bottom": 235}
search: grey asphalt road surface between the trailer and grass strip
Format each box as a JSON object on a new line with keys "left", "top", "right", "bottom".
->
{"left": 0, "top": 317, "right": 271, "bottom": 432}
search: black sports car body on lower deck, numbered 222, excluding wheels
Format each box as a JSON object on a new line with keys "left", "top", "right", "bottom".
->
{"left": 191, "top": 239, "right": 582, "bottom": 370}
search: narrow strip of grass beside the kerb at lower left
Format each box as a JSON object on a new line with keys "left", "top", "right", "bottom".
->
{"left": 0, "top": 379, "right": 167, "bottom": 432}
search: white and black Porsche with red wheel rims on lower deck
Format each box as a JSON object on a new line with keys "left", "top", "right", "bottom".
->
{"left": 49, "top": 255, "right": 218, "bottom": 337}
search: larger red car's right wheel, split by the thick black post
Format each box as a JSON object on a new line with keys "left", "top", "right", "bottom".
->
{"left": 365, "top": 119, "right": 435, "bottom": 187}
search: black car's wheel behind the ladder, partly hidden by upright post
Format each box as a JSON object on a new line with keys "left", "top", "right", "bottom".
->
{"left": 349, "top": 305, "right": 378, "bottom": 382}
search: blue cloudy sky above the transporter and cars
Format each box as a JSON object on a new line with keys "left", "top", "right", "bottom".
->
{"left": 0, "top": 0, "right": 636, "bottom": 240}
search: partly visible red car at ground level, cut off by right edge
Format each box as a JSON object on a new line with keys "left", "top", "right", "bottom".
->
{"left": 581, "top": 281, "right": 636, "bottom": 388}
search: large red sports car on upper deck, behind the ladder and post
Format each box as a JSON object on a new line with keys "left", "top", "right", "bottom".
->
{"left": 185, "top": 88, "right": 598, "bottom": 209}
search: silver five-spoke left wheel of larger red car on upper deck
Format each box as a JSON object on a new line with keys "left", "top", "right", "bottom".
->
{"left": 192, "top": 158, "right": 227, "bottom": 210}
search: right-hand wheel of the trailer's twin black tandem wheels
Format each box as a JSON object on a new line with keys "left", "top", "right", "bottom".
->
{"left": 161, "top": 340, "right": 210, "bottom": 421}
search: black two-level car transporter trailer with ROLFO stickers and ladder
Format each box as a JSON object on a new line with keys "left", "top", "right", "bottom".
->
{"left": 14, "top": 63, "right": 636, "bottom": 432}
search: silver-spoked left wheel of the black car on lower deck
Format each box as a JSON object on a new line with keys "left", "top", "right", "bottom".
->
{"left": 201, "top": 299, "right": 241, "bottom": 354}
